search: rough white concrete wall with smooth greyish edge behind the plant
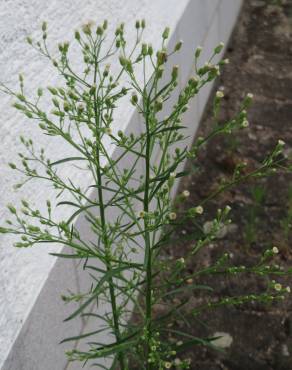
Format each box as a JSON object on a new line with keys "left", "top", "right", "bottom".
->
{"left": 0, "top": 0, "right": 241, "bottom": 370}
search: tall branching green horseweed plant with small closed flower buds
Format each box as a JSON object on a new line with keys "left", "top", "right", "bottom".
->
{"left": 0, "top": 20, "right": 290, "bottom": 370}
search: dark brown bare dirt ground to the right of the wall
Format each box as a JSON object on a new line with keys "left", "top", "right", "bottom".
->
{"left": 169, "top": 0, "right": 292, "bottom": 370}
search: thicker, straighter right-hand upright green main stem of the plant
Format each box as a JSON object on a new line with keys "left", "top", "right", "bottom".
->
{"left": 144, "top": 99, "right": 152, "bottom": 370}
